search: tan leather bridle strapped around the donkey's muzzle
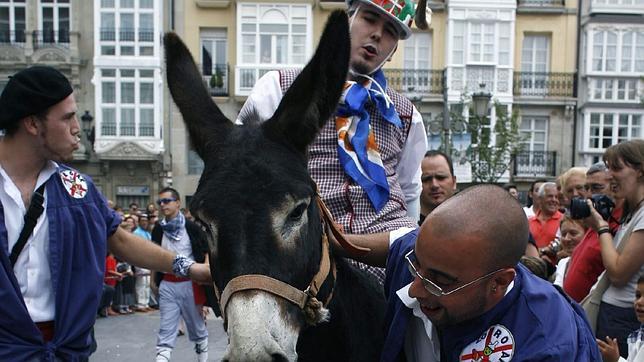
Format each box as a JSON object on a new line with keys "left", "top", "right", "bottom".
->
{"left": 214, "top": 194, "right": 370, "bottom": 326}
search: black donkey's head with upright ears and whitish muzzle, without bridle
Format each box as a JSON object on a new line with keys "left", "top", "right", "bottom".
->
{"left": 165, "top": 11, "right": 350, "bottom": 361}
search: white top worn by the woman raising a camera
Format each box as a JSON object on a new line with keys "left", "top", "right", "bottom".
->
{"left": 602, "top": 206, "right": 644, "bottom": 308}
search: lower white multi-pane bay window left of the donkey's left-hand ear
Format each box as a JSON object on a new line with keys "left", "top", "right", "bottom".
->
{"left": 97, "top": 69, "right": 156, "bottom": 137}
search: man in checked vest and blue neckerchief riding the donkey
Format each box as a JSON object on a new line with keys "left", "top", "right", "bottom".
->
{"left": 237, "top": 0, "right": 427, "bottom": 282}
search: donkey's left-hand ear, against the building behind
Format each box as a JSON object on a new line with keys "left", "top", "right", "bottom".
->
{"left": 163, "top": 33, "right": 233, "bottom": 160}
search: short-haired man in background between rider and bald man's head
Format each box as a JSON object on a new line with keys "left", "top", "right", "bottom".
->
{"left": 418, "top": 150, "right": 456, "bottom": 225}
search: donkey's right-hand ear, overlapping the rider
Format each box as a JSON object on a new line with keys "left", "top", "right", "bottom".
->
{"left": 263, "top": 10, "right": 351, "bottom": 153}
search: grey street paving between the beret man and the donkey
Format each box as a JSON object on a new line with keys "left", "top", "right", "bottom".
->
{"left": 90, "top": 311, "right": 227, "bottom": 362}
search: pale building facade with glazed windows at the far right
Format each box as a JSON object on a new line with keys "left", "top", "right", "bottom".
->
{"left": 575, "top": 0, "right": 644, "bottom": 165}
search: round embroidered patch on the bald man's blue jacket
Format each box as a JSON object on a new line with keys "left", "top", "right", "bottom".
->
{"left": 460, "top": 324, "right": 514, "bottom": 362}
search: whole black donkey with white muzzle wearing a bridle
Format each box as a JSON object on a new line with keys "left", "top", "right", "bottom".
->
{"left": 164, "top": 11, "right": 385, "bottom": 361}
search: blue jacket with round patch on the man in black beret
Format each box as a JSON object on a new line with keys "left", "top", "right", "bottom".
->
{"left": 0, "top": 165, "right": 121, "bottom": 361}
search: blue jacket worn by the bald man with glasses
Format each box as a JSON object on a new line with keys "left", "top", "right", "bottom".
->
{"left": 382, "top": 232, "right": 601, "bottom": 362}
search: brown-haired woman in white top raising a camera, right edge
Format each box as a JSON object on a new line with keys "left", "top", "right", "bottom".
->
{"left": 586, "top": 140, "right": 644, "bottom": 357}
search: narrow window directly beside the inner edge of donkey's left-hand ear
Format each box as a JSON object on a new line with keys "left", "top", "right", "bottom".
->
{"left": 201, "top": 29, "right": 228, "bottom": 96}
